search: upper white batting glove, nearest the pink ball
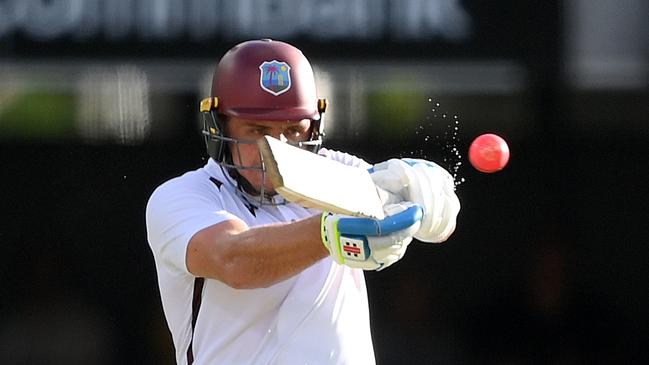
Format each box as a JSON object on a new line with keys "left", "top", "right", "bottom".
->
{"left": 370, "top": 158, "right": 460, "bottom": 242}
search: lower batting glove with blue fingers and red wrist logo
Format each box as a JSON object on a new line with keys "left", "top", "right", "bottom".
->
{"left": 320, "top": 202, "right": 423, "bottom": 270}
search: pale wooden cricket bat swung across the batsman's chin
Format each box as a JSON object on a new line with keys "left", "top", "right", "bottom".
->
{"left": 257, "top": 136, "right": 384, "bottom": 219}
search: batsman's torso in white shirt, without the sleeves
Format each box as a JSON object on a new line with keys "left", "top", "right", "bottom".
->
{"left": 159, "top": 162, "right": 374, "bottom": 364}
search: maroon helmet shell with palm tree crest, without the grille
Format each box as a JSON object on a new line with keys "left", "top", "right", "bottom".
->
{"left": 212, "top": 39, "right": 320, "bottom": 120}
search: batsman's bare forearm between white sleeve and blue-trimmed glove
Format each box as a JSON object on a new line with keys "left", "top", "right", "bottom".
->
{"left": 186, "top": 216, "right": 329, "bottom": 289}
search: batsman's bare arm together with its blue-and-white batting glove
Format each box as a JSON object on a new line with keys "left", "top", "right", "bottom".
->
{"left": 186, "top": 203, "right": 422, "bottom": 289}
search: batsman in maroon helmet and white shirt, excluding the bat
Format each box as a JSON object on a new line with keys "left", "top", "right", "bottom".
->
{"left": 146, "top": 39, "right": 460, "bottom": 365}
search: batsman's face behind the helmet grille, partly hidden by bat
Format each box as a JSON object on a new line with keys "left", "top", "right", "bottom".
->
{"left": 226, "top": 118, "right": 311, "bottom": 193}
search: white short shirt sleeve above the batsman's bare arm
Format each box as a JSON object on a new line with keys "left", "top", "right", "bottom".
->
{"left": 146, "top": 180, "right": 238, "bottom": 274}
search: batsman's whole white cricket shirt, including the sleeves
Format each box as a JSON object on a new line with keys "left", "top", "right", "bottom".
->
{"left": 146, "top": 149, "right": 375, "bottom": 365}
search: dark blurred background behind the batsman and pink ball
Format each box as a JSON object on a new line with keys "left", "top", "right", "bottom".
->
{"left": 0, "top": 0, "right": 649, "bottom": 364}
